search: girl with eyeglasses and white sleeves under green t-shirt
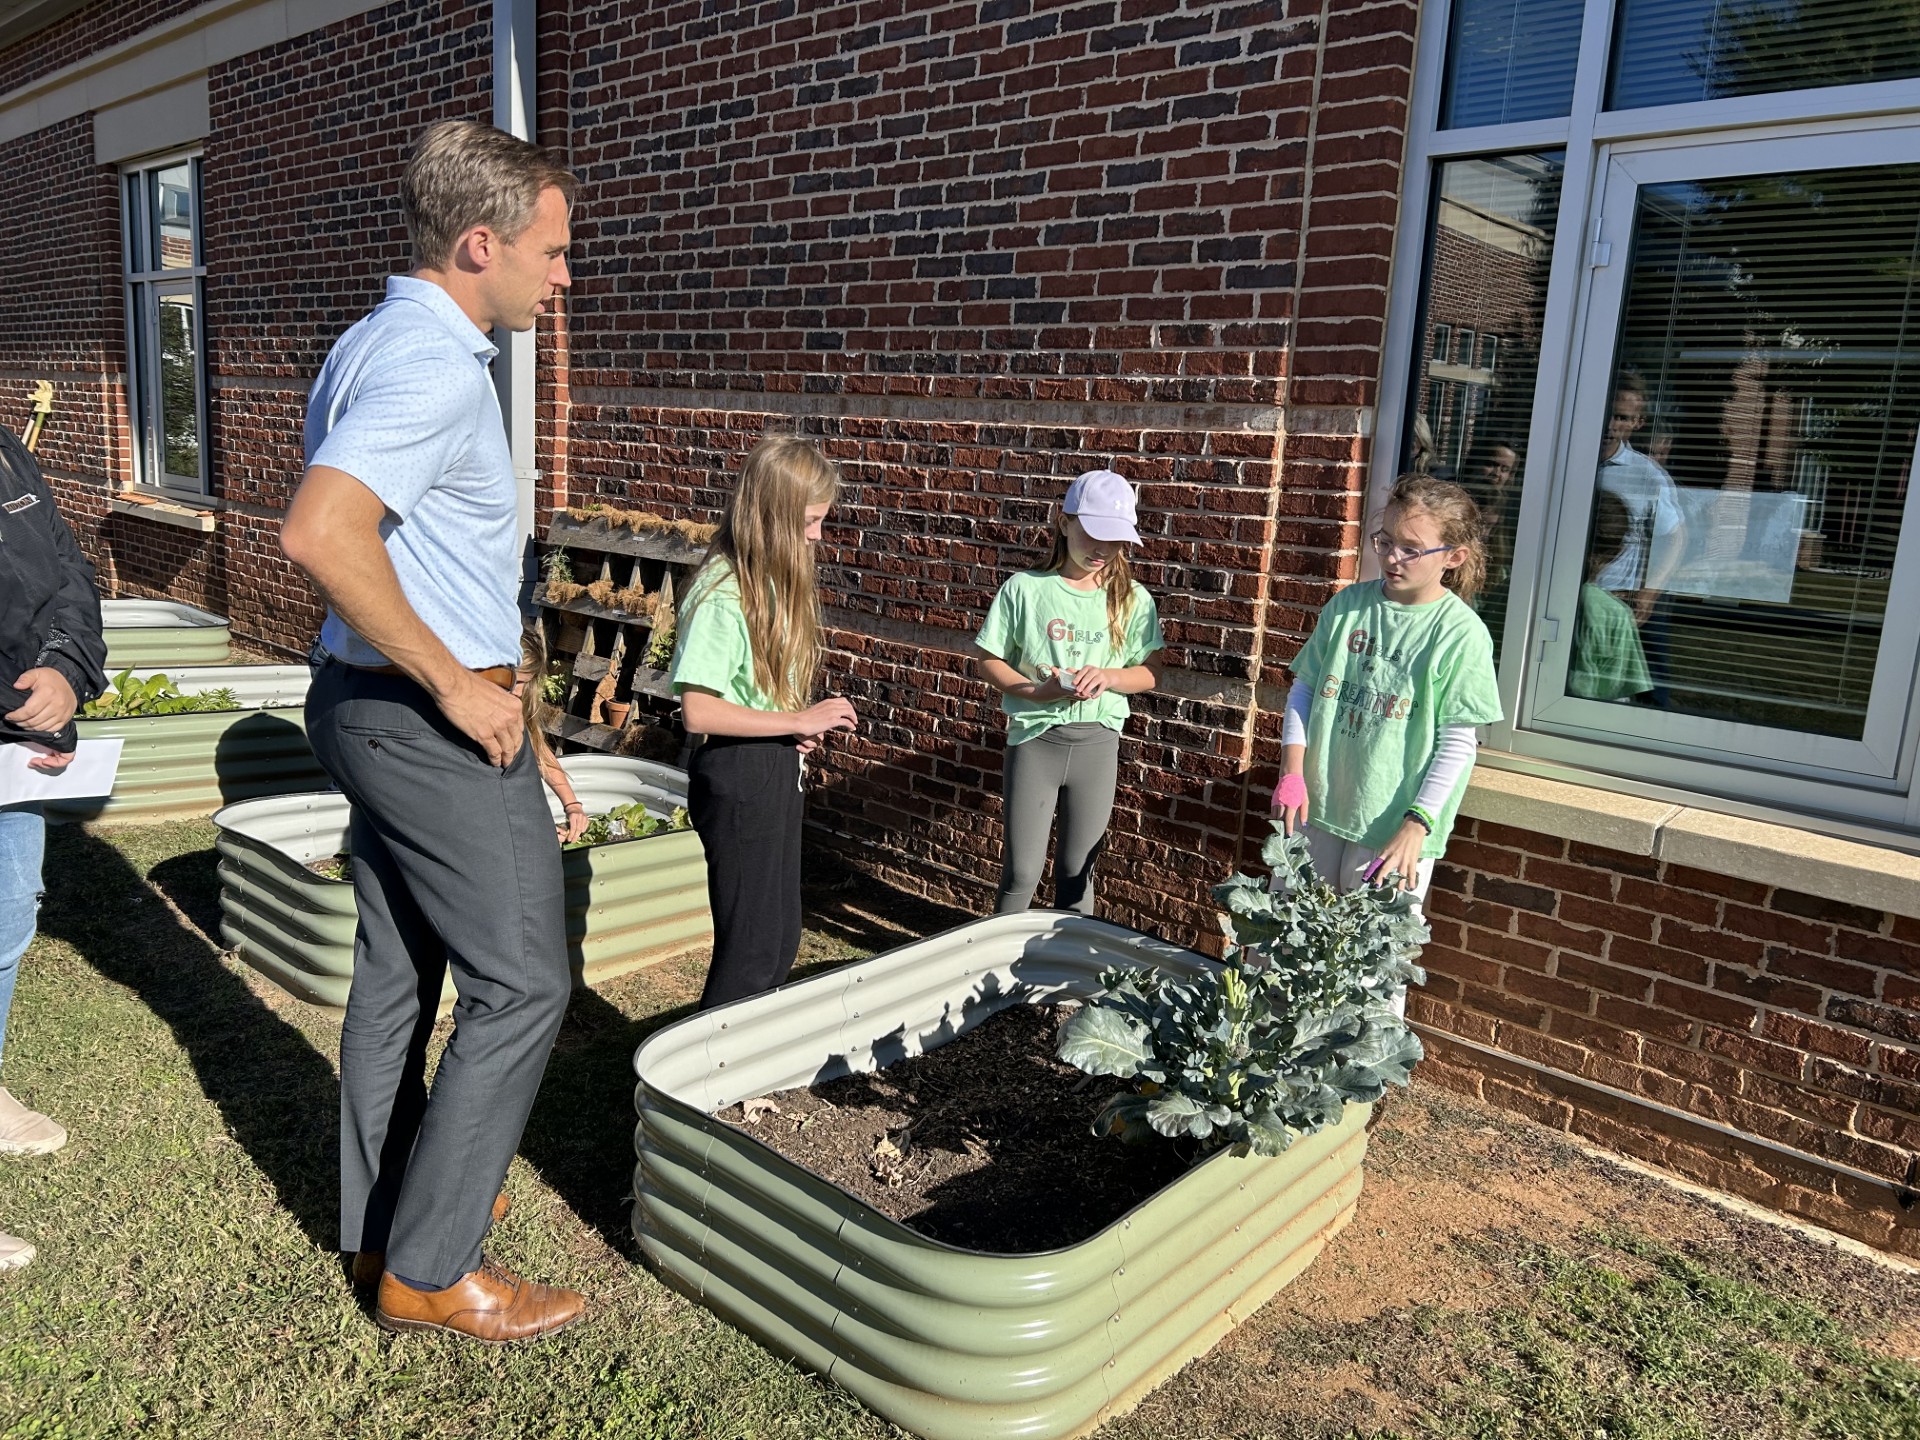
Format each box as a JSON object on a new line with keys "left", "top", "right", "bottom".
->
{"left": 1273, "top": 474, "right": 1500, "bottom": 940}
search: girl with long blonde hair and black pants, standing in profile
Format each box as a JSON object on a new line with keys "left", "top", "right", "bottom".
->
{"left": 672, "top": 436, "right": 858, "bottom": 1010}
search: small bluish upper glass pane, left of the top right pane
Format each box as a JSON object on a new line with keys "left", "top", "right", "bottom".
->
{"left": 1440, "top": 0, "right": 1582, "bottom": 131}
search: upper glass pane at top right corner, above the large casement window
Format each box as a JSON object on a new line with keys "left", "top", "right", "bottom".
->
{"left": 1607, "top": 0, "right": 1920, "bottom": 109}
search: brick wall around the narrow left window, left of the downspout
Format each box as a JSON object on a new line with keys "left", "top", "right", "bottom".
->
{"left": 0, "top": 0, "right": 493, "bottom": 651}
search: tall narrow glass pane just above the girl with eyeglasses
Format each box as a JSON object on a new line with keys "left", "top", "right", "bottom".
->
{"left": 1400, "top": 150, "right": 1563, "bottom": 664}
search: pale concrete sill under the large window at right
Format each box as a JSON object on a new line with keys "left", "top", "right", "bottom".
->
{"left": 1459, "top": 760, "right": 1920, "bottom": 918}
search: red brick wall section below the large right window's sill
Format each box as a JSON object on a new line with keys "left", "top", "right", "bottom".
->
{"left": 1407, "top": 820, "right": 1920, "bottom": 1254}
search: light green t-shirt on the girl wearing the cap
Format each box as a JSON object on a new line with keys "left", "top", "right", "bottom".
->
{"left": 973, "top": 570, "right": 1165, "bottom": 745}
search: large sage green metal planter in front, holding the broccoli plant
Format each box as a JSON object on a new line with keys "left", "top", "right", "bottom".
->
{"left": 634, "top": 912, "right": 1369, "bottom": 1440}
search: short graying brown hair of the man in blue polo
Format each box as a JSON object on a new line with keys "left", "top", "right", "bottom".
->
{"left": 399, "top": 121, "right": 580, "bottom": 269}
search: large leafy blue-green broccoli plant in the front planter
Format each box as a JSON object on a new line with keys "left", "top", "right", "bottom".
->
{"left": 1060, "top": 826, "right": 1427, "bottom": 1156}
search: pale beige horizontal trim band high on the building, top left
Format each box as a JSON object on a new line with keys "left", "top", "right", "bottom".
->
{"left": 0, "top": 0, "right": 380, "bottom": 144}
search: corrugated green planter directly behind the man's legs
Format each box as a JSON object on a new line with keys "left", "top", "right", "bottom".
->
{"left": 213, "top": 755, "right": 712, "bottom": 1008}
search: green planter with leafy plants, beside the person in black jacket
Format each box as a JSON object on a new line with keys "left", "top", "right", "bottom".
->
{"left": 46, "top": 664, "right": 326, "bottom": 824}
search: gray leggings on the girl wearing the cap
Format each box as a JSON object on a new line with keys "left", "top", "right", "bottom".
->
{"left": 993, "top": 720, "right": 1119, "bottom": 916}
